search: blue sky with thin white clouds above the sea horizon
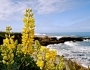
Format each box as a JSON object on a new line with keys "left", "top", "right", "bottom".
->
{"left": 0, "top": 0, "right": 90, "bottom": 33}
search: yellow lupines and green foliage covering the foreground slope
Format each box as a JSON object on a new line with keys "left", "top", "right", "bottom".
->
{"left": 0, "top": 9, "right": 90, "bottom": 70}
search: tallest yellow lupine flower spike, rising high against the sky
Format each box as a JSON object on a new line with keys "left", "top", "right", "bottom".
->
{"left": 22, "top": 9, "right": 35, "bottom": 54}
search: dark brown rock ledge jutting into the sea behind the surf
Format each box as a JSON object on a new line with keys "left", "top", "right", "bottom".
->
{"left": 34, "top": 36, "right": 90, "bottom": 46}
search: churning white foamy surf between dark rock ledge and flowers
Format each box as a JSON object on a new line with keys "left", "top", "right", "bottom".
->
{"left": 47, "top": 41, "right": 90, "bottom": 67}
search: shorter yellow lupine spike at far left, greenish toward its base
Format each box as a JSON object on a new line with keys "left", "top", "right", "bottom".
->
{"left": 1, "top": 26, "right": 15, "bottom": 65}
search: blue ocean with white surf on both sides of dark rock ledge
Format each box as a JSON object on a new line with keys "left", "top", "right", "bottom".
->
{"left": 35, "top": 32, "right": 90, "bottom": 68}
